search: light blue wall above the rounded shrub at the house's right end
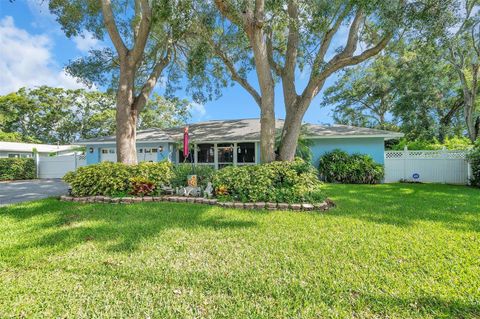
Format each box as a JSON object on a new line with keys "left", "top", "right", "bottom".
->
{"left": 311, "top": 137, "right": 385, "bottom": 167}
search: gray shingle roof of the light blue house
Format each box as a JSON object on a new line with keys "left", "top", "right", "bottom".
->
{"left": 80, "top": 119, "right": 403, "bottom": 144}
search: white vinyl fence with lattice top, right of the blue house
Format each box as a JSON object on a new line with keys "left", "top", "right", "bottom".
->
{"left": 385, "top": 149, "right": 469, "bottom": 185}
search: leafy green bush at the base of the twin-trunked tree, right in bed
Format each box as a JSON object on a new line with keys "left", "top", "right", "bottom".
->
{"left": 213, "top": 158, "right": 324, "bottom": 203}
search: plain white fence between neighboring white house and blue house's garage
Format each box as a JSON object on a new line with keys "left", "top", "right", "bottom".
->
{"left": 36, "top": 154, "right": 87, "bottom": 178}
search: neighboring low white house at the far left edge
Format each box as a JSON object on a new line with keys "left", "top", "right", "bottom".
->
{"left": 0, "top": 141, "right": 78, "bottom": 158}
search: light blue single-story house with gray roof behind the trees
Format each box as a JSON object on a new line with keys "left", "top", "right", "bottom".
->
{"left": 77, "top": 119, "right": 403, "bottom": 169}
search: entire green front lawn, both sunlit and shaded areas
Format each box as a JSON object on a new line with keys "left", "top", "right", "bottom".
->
{"left": 0, "top": 184, "right": 480, "bottom": 318}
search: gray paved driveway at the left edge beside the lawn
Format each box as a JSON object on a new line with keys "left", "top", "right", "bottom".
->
{"left": 0, "top": 179, "right": 68, "bottom": 206}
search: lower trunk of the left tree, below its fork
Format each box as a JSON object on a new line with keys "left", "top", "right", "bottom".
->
{"left": 116, "top": 65, "right": 138, "bottom": 165}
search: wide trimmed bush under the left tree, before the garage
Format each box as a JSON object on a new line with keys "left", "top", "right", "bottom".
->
{"left": 63, "top": 161, "right": 173, "bottom": 196}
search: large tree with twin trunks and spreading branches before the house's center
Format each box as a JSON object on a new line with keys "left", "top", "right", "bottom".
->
{"left": 188, "top": 0, "right": 449, "bottom": 162}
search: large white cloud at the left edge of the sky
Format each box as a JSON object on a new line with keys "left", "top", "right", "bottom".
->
{"left": 0, "top": 16, "right": 87, "bottom": 94}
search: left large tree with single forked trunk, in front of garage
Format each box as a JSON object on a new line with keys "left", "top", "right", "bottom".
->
{"left": 49, "top": 0, "right": 191, "bottom": 164}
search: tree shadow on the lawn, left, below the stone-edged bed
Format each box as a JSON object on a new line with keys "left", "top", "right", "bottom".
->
{"left": 0, "top": 199, "right": 255, "bottom": 257}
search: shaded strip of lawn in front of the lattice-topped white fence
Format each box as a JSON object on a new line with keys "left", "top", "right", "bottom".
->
{"left": 325, "top": 184, "right": 480, "bottom": 232}
